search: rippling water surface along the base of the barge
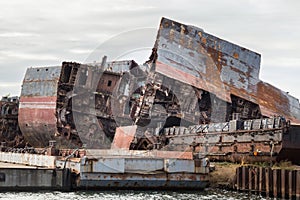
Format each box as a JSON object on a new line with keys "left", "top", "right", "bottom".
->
{"left": 0, "top": 189, "right": 276, "bottom": 200}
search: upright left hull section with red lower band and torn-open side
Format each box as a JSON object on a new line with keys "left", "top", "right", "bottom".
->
{"left": 19, "top": 61, "right": 144, "bottom": 148}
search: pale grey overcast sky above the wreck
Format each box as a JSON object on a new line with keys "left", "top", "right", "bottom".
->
{"left": 0, "top": 0, "right": 300, "bottom": 98}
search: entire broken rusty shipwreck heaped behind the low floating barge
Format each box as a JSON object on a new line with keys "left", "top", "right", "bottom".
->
{"left": 0, "top": 18, "right": 300, "bottom": 163}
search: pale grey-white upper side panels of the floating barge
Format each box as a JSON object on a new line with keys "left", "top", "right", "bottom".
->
{"left": 56, "top": 156, "right": 202, "bottom": 174}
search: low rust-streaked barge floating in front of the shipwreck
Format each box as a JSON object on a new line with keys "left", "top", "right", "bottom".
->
{"left": 0, "top": 150, "right": 209, "bottom": 190}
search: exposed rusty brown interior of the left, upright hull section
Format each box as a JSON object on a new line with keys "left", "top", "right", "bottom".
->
{"left": 56, "top": 61, "right": 142, "bottom": 148}
